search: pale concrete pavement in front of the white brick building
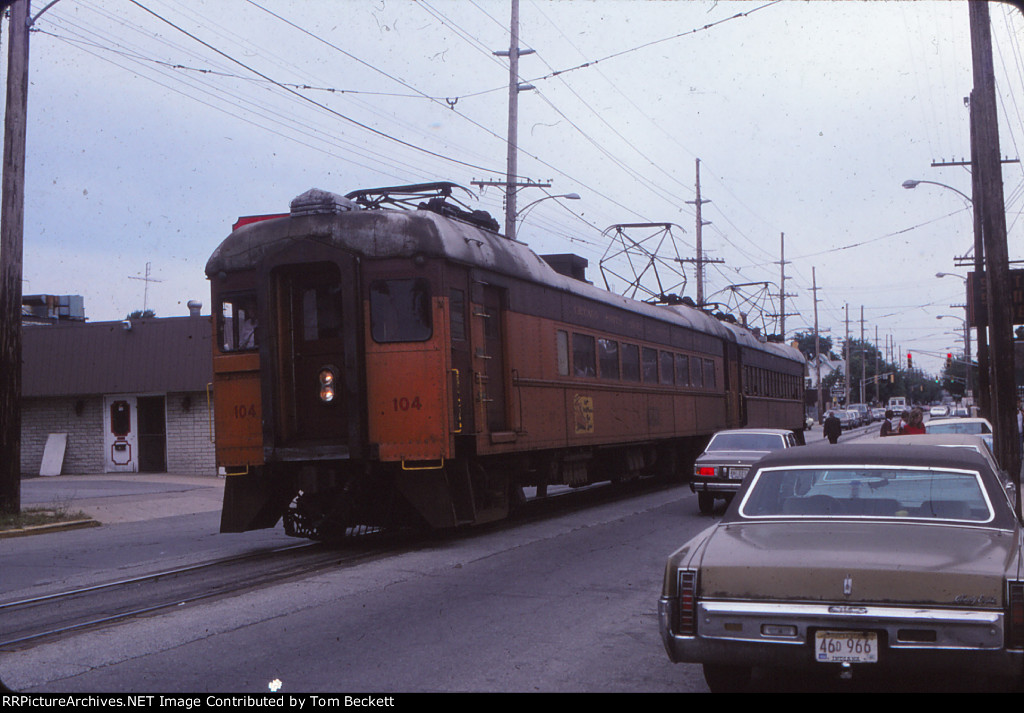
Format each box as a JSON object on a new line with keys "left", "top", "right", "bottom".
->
{"left": 7, "top": 473, "right": 224, "bottom": 537}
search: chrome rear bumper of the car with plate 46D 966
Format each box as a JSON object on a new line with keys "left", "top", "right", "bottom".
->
{"left": 658, "top": 597, "right": 1024, "bottom": 677}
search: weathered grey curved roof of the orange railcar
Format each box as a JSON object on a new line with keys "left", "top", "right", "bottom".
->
{"left": 206, "top": 190, "right": 804, "bottom": 362}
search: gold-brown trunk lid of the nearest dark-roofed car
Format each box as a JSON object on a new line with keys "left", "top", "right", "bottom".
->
{"left": 699, "top": 520, "right": 1015, "bottom": 607}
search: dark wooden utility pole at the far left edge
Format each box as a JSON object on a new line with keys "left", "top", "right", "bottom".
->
{"left": 0, "top": 0, "right": 29, "bottom": 513}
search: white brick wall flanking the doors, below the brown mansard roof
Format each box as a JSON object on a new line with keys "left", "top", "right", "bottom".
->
{"left": 22, "top": 391, "right": 217, "bottom": 475}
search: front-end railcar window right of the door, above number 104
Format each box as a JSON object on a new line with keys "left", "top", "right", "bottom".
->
{"left": 370, "top": 278, "right": 433, "bottom": 343}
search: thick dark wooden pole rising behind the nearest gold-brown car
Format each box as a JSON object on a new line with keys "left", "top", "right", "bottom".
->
{"left": 969, "top": 0, "right": 1021, "bottom": 495}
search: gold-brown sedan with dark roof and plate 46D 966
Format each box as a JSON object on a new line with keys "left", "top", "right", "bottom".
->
{"left": 658, "top": 446, "right": 1024, "bottom": 690}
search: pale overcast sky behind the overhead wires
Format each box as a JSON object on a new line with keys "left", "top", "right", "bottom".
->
{"left": 9, "top": 0, "right": 1024, "bottom": 371}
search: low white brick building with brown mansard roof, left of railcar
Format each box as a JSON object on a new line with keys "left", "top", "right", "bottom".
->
{"left": 22, "top": 304, "right": 216, "bottom": 475}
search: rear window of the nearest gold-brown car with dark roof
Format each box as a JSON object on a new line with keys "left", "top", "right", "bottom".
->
{"left": 739, "top": 466, "right": 993, "bottom": 522}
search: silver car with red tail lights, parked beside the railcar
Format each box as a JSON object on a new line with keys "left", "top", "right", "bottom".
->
{"left": 690, "top": 428, "right": 800, "bottom": 514}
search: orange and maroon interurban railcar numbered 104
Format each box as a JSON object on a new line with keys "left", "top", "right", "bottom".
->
{"left": 206, "top": 183, "right": 804, "bottom": 538}
